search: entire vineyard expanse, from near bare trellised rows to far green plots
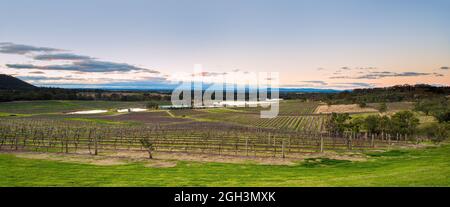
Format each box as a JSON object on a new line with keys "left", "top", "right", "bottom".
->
{"left": 0, "top": 101, "right": 432, "bottom": 158}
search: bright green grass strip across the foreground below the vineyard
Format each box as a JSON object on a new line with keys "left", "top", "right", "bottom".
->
{"left": 0, "top": 145, "right": 450, "bottom": 186}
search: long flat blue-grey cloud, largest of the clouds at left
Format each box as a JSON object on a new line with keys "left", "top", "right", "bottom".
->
{"left": 6, "top": 60, "right": 159, "bottom": 73}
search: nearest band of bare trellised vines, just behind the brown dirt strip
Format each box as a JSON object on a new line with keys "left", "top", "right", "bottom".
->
{"left": 0, "top": 119, "right": 418, "bottom": 158}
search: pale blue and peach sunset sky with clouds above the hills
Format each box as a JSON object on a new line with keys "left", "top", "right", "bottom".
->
{"left": 0, "top": 0, "right": 450, "bottom": 89}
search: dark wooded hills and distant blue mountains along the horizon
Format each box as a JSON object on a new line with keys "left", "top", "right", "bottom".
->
{"left": 0, "top": 74, "right": 450, "bottom": 104}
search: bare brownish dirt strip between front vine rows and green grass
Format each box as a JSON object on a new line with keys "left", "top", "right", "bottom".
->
{"left": 0, "top": 147, "right": 367, "bottom": 168}
